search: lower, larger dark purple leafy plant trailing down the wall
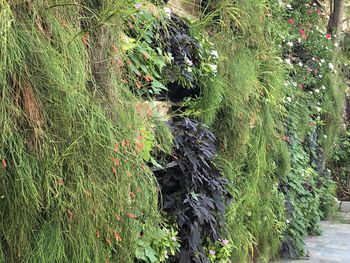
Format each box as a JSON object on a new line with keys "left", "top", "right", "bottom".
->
{"left": 156, "top": 118, "right": 230, "bottom": 262}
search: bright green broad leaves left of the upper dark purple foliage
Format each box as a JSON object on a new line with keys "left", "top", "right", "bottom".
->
{"left": 119, "top": 2, "right": 172, "bottom": 96}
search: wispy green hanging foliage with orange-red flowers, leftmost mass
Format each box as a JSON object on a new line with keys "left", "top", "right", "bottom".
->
{"left": 0, "top": 1, "right": 167, "bottom": 262}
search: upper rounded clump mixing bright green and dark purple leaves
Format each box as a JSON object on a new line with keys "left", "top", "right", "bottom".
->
{"left": 117, "top": 2, "right": 218, "bottom": 109}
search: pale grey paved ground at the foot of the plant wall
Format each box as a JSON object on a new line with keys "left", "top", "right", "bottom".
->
{"left": 275, "top": 213, "right": 350, "bottom": 263}
